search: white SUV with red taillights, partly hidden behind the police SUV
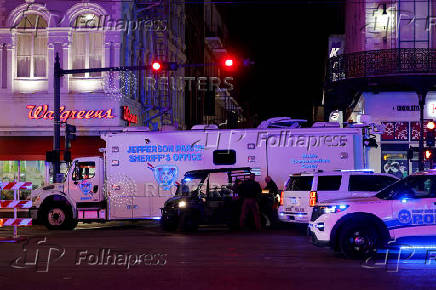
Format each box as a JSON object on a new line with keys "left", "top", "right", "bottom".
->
{"left": 279, "top": 170, "right": 398, "bottom": 223}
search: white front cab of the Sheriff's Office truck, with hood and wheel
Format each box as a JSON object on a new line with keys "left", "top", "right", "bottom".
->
{"left": 30, "top": 157, "right": 107, "bottom": 229}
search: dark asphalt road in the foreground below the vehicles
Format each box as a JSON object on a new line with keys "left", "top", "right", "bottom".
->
{"left": 0, "top": 223, "right": 436, "bottom": 290}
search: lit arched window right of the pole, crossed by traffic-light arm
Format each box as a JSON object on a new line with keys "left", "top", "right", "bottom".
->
{"left": 71, "top": 14, "right": 104, "bottom": 77}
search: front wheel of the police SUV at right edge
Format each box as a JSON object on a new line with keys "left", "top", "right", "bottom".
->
{"left": 339, "top": 225, "right": 379, "bottom": 259}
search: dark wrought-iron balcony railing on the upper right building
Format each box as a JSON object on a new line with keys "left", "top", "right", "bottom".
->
{"left": 327, "top": 48, "right": 436, "bottom": 83}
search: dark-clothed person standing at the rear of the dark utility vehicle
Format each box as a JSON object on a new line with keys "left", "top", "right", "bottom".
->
{"left": 239, "top": 173, "right": 262, "bottom": 231}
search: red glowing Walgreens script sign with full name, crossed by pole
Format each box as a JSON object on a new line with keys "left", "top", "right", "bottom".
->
{"left": 26, "top": 105, "right": 115, "bottom": 122}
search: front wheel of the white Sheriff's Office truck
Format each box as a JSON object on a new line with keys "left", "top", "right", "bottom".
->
{"left": 42, "top": 204, "right": 77, "bottom": 230}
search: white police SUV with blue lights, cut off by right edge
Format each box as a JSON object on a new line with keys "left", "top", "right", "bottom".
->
{"left": 309, "top": 171, "right": 436, "bottom": 258}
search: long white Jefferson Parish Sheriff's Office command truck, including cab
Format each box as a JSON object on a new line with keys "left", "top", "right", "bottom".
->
{"left": 31, "top": 122, "right": 364, "bottom": 229}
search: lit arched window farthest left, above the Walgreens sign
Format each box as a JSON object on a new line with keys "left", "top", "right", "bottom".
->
{"left": 17, "top": 14, "right": 47, "bottom": 78}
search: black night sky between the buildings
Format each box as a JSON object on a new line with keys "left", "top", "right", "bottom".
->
{"left": 219, "top": 0, "right": 345, "bottom": 122}
